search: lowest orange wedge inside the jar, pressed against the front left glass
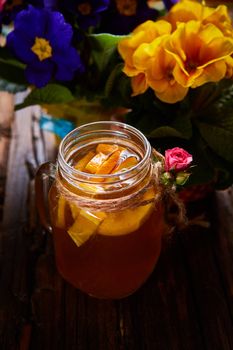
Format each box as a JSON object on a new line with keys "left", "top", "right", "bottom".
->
{"left": 67, "top": 210, "right": 106, "bottom": 247}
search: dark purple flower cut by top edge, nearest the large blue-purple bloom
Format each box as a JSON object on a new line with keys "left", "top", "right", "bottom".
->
{"left": 58, "top": 0, "right": 110, "bottom": 30}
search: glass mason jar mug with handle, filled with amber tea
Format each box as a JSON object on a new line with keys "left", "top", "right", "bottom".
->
{"left": 36, "top": 122, "right": 164, "bottom": 298}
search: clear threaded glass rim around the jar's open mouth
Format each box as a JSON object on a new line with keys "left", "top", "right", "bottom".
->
{"left": 58, "top": 121, "right": 151, "bottom": 182}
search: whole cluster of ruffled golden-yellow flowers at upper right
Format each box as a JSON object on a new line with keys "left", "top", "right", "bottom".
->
{"left": 118, "top": 0, "right": 233, "bottom": 103}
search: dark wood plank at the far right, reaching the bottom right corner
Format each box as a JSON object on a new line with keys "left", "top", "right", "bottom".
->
{"left": 180, "top": 196, "right": 233, "bottom": 350}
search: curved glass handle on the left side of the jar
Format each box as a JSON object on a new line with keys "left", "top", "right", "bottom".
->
{"left": 35, "top": 162, "right": 56, "bottom": 233}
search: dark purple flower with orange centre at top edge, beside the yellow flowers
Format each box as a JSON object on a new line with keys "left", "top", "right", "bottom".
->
{"left": 99, "top": 0, "right": 158, "bottom": 34}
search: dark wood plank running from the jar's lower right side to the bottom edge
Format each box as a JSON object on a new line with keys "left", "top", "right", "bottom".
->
{"left": 117, "top": 239, "right": 203, "bottom": 349}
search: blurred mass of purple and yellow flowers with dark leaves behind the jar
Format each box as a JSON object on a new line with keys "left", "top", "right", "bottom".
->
{"left": 0, "top": 0, "right": 233, "bottom": 193}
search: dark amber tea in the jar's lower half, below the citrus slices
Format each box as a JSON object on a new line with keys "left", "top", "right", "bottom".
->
{"left": 50, "top": 182, "right": 163, "bottom": 298}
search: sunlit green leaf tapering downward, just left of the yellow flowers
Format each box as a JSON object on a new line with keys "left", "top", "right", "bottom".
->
{"left": 89, "top": 33, "right": 125, "bottom": 72}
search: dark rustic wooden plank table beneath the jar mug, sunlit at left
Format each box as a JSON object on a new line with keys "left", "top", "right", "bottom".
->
{"left": 0, "top": 93, "right": 233, "bottom": 350}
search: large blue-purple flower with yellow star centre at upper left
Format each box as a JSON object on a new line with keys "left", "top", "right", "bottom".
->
{"left": 7, "top": 5, "right": 83, "bottom": 87}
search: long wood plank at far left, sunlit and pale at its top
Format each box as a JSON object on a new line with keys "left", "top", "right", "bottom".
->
{"left": 0, "top": 96, "right": 56, "bottom": 350}
